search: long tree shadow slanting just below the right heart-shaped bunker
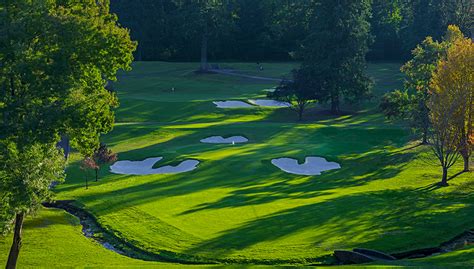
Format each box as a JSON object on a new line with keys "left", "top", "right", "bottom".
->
{"left": 179, "top": 148, "right": 414, "bottom": 215}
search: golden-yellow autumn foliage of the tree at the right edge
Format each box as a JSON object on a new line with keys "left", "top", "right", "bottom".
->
{"left": 429, "top": 35, "right": 474, "bottom": 172}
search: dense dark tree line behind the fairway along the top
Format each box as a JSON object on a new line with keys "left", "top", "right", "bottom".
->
{"left": 111, "top": 0, "right": 474, "bottom": 61}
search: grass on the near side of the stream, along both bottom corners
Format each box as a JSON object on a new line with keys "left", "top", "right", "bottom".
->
{"left": 0, "top": 209, "right": 474, "bottom": 269}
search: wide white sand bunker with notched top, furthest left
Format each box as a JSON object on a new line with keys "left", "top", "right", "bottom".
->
{"left": 110, "top": 157, "right": 199, "bottom": 175}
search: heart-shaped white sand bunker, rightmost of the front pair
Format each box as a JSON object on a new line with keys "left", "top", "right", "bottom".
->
{"left": 272, "top": 157, "right": 341, "bottom": 176}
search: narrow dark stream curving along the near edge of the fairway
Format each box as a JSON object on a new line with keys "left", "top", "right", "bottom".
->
{"left": 43, "top": 200, "right": 474, "bottom": 265}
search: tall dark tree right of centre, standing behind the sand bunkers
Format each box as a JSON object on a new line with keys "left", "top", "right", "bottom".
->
{"left": 301, "top": 0, "right": 371, "bottom": 114}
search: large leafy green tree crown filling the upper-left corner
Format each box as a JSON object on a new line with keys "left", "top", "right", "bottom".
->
{"left": 0, "top": 1, "right": 135, "bottom": 152}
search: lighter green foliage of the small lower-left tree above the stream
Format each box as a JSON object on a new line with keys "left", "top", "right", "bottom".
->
{"left": 0, "top": 141, "right": 65, "bottom": 232}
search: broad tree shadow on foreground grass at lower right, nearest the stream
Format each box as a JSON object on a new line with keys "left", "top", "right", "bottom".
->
{"left": 185, "top": 186, "right": 474, "bottom": 258}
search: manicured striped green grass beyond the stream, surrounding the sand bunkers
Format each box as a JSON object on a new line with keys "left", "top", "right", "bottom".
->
{"left": 0, "top": 63, "right": 474, "bottom": 266}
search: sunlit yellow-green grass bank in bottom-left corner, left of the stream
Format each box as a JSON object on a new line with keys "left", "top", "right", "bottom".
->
{"left": 0, "top": 209, "right": 176, "bottom": 268}
